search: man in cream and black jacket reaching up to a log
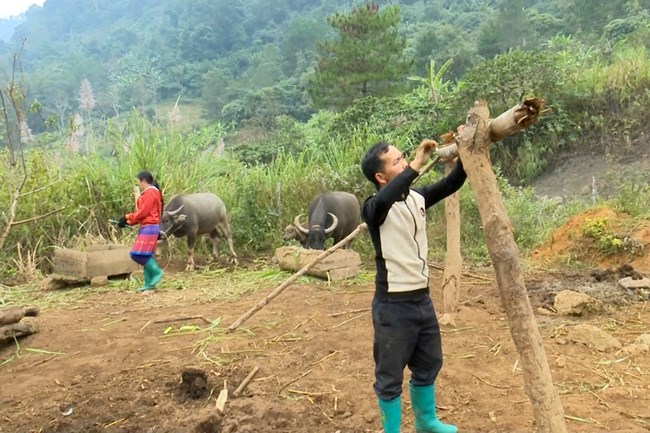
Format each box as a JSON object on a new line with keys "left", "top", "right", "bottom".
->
{"left": 361, "top": 140, "right": 466, "bottom": 433}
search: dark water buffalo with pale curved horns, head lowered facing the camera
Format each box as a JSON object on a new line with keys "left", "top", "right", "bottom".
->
{"left": 292, "top": 191, "right": 361, "bottom": 250}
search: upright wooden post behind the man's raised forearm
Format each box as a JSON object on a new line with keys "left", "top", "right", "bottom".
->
{"left": 439, "top": 159, "right": 463, "bottom": 326}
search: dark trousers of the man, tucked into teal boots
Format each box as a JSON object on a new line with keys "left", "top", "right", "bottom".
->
{"left": 372, "top": 295, "right": 442, "bottom": 400}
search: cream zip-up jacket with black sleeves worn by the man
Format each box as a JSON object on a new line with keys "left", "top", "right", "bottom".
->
{"left": 362, "top": 161, "right": 466, "bottom": 299}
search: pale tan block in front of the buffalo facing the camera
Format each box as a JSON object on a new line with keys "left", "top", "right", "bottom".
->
{"left": 275, "top": 246, "right": 361, "bottom": 281}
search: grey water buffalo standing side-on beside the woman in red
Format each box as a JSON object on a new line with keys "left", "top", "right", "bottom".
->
{"left": 161, "top": 192, "right": 237, "bottom": 270}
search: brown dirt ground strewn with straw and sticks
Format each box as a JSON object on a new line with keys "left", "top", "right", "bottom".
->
{"left": 0, "top": 260, "right": 650, "bottom": 433}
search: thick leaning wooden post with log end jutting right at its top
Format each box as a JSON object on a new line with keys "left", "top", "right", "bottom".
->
{"left": 458, "top": 99, "right": 567, "bottom": 433}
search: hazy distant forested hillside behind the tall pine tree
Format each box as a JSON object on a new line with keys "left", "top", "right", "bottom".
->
{"left": 6, "top": 0, "right": 650, "bottom": 132}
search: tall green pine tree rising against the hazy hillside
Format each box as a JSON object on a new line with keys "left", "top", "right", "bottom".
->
{"left": 309, "top": 3, "right": 413, "bottom": 109}
